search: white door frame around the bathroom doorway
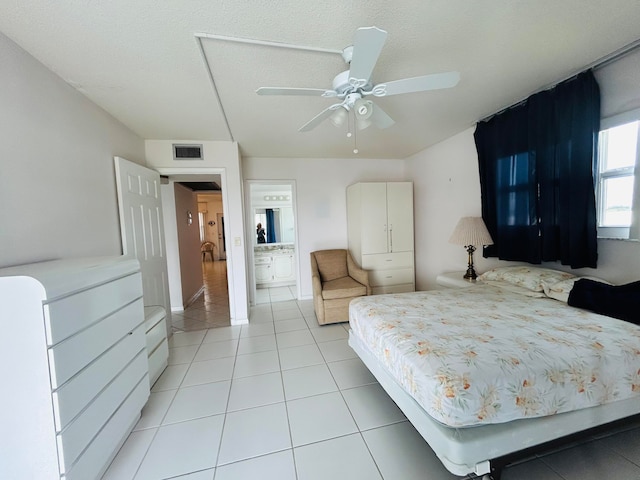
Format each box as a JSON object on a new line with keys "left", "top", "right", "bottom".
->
{"left": 244, "top": 180, "right": 301, "bottom": 306}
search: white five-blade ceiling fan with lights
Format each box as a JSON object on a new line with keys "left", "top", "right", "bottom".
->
{"left": 256, "top": 27, "right": 460, "bottom": 132}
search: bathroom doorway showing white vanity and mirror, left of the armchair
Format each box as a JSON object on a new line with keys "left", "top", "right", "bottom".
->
{"left": 245, "top": 180, "right": 300, "bottom": 305}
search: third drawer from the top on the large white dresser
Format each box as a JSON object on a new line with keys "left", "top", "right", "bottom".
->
{"left": 53, "top": 325, "right": 144, "bottom": 432}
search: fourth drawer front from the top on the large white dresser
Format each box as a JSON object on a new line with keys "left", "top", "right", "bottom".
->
{"left": 57, "top": 351, "right": 148, "bottom": 472}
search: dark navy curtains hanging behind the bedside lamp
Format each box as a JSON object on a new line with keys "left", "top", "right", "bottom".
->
{"left": 474, "top": 70, "right": 600, "bottom": 268}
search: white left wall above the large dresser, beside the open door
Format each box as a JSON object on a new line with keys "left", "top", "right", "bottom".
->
{"left": 0, "top": 34, "right": 144, "bottom": 267}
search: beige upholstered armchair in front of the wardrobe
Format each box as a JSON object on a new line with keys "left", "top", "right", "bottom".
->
{"left": 311, "top": 249, "right": 371, "bottom": 325}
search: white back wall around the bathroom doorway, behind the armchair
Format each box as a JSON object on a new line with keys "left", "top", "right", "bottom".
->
{"left": 242, "top": 158, "right": 410, "bottom": 298}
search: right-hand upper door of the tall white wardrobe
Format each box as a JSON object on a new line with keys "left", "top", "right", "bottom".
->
{"left": 387, "top": 182, "right": 413, "bottom": 252}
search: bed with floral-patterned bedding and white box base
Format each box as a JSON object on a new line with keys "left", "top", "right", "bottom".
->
{"left": 349, "top": 267, "right": 640, "bottom": 478}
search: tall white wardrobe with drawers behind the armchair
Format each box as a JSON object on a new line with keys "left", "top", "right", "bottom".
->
{"left": 347, "top": 182, "right": 416, "bottom": 294}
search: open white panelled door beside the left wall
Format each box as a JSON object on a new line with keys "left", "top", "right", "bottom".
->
{"left": 114, "top": 157, "right": 171, "bottom": 329}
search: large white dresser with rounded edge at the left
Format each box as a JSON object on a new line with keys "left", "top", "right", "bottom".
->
{"left": 0, "top": 257, "right": 149, "bottom": 480}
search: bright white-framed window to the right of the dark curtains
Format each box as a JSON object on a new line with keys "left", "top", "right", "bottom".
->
{"left": 596, "top": 111, "right": 640, "bottom": 239}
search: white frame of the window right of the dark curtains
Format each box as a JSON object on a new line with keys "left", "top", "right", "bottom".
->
{"left": 595, "top": 108, "right": 640, "bottom": 240}
